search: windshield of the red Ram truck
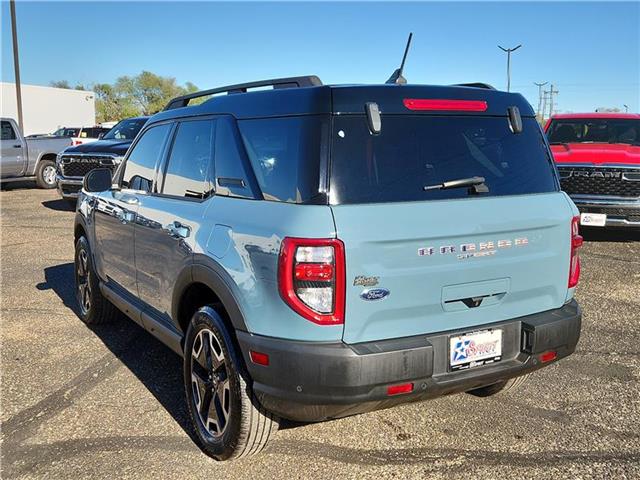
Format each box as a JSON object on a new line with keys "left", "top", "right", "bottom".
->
{"left": 547, "top": 118, "right": 640, "bottom": 145}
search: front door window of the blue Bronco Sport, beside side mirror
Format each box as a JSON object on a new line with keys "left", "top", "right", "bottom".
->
{"left": 122, "top": 124, "right": 171, "bottom": 192}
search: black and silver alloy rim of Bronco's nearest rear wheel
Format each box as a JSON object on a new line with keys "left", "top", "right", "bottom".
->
{"left": 191, "top": 328, "right": 231, "bottom": 437}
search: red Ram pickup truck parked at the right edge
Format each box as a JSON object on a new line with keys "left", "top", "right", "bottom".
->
{"left": 545, "top": 113, "right": 640, "bottom": 228}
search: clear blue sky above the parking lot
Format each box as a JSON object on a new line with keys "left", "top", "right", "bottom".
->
{"left": 0, "top": 0, "right": 640, "bottom": 112}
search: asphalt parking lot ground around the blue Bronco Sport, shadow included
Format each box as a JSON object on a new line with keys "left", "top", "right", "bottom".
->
{"left": 0, "top": 184, "right": 640, "bottom": 479}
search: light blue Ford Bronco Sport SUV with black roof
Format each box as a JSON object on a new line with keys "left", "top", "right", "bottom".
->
{"left": 74, "top": 76, "right": 582, "bottom": 460}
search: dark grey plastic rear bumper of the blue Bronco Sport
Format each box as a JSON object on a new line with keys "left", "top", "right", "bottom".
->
{"left": 237, "top": 300, "right": 582, "bottom": 422}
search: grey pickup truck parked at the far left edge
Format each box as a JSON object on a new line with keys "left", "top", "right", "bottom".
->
{"left": 0, "top": 117, "right": 71, "bottom": 188}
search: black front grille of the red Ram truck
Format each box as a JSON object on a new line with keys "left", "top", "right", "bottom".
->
{"left": 558, "top": 165, "right": 640, "bottom": 197}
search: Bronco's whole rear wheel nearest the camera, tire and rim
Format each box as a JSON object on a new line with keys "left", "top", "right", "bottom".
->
{"left": 184, "top": 306, "right": 278, "bottom": 460}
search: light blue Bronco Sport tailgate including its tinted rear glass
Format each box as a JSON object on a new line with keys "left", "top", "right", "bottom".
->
{"left": 330, "top": 110, "right": 572, "bottom": 343}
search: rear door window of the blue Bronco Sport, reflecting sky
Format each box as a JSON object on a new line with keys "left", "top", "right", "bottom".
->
{"left": 162, "top": 120, "right": 214, "bottom": 198}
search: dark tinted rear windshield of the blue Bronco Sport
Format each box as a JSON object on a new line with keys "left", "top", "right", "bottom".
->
{"left": 330, "top": 118, "right": 558, "bottom": 204}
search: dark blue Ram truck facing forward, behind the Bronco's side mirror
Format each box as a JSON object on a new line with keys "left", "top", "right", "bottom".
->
{"left": 57, "top": 117, "right": 148, "bottom": 204}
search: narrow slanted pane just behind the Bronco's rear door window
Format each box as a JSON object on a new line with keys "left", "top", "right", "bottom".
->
{"left": 215, "top": 117, "right": 253, "bottom": 198}
